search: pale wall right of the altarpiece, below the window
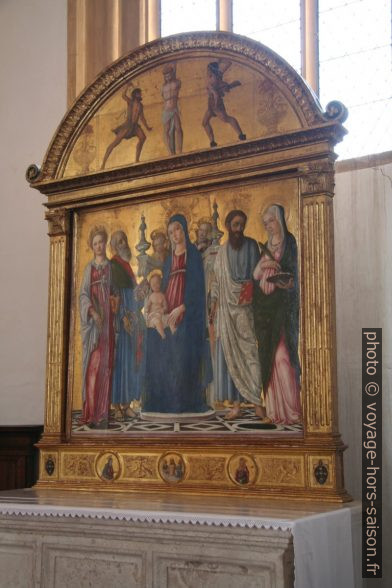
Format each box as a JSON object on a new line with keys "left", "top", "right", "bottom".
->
{"left": 334, "top": 161, "right": 392, "bottom": 587}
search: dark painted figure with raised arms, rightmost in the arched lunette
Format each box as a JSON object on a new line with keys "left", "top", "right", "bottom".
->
{"left": 202, "top": 59, "right": 246, "bottom": 147}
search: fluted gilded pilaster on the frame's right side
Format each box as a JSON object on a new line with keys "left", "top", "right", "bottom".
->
{"left": 301, "top": 161, "right": 337, "bottom": 434}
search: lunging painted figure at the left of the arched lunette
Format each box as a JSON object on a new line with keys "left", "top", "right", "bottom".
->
{"left": 101, "top": 86, "right": 152, "bottom": 169}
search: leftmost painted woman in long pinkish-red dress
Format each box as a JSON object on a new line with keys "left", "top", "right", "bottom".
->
{"left": 80, "top": 227, "right": 115, "bottom": 428}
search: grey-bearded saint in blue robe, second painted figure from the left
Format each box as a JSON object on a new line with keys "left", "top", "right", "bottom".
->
{"left": 110, "top": 231, "right": 145, "bottom": 420}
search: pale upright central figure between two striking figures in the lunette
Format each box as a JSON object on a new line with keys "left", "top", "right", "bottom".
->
{"left": 162, "top": 63, "right": 183, "bottom": 155}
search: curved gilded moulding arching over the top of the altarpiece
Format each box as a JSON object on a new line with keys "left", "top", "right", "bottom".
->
{"left": 27, "top": 32, "right": 344, "bottom": 185}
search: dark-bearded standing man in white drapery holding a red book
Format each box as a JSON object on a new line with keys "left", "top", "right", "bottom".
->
{"left": 209, "top": 210, "right": 265, "bottom": 420}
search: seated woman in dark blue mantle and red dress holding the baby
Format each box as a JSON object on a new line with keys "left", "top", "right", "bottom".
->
{"left": 142, "top": 214, "right": 213, "bottom": 418}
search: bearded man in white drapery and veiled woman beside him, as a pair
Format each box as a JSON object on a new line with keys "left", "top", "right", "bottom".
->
{"left": 209, "top": 204, "right": 302, "bottom": 424}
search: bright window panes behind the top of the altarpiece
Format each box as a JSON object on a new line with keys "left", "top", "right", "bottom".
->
{"left": 161, "top": 0, "right": 392, "bottom": 158}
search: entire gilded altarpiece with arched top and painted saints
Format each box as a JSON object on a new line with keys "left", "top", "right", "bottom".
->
{"left": 27, "top": 33, "right": 349, "bottom": 501}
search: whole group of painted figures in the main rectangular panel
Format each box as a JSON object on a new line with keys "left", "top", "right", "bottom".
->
{"left": 80, "top": 205, "right": 301, "bottom": 428}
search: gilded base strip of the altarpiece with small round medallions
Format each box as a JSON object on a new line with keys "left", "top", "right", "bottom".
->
{"left": 37, "top": 447, "right": 350, "bottom": 502}
